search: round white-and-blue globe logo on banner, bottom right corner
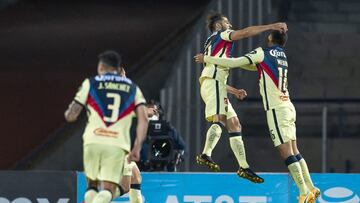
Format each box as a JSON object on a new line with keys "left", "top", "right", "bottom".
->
{"left": 319, "top": 187, "right": 360, "bottom": 203}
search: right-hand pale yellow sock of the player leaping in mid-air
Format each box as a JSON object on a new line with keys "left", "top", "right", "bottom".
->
{"left": 229, "top": 132, "right": 249, "bottom": 168}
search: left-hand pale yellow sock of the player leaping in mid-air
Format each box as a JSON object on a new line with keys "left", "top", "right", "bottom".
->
{"left": 203, "top": 122, "right": 224, "bottom": 156}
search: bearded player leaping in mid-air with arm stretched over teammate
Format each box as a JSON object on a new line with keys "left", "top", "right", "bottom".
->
{"left": 196, "top": 13, "right": 287, "bottom": 183}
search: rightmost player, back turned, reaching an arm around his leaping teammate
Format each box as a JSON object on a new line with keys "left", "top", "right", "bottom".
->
{"left": 195, "top": 31, "right": 320, "bottom": 203}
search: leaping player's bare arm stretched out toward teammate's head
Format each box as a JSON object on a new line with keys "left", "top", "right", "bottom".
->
{"left": 230, "top": 23, "right": 288, "bottom": 41}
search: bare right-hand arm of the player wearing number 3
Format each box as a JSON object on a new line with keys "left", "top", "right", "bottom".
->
{"left": 128, "top": 105, "right": 149, "bottom": 163}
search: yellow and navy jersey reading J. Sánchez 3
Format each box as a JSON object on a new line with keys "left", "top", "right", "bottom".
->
{"left": 82, "top": 73, "right": 145, "bottom": 151}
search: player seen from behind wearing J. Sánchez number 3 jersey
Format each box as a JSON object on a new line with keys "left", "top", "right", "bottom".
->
{"left": 65, "top": 51, "right": 148, "bottom": 203}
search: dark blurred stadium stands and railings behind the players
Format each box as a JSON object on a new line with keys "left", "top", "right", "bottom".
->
{"left": 0, "top": 0, "right": 360, "bottom": 172}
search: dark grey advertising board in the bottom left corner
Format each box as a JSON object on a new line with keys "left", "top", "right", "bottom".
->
{"left": 0, "top": 171, "right": 77, "bottom": 203}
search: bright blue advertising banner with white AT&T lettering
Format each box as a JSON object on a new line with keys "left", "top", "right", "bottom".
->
{"left": 78, "top": 173, "right": 360, "bottom": 203}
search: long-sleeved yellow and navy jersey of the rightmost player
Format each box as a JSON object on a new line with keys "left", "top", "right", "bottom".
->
{"left": 204, "top": 46, "right": 290, "bottom": 111}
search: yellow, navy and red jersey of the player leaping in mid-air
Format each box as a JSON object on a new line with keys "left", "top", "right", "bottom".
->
{"left": 199, "top": 30, "right": 234, "bottom": 84}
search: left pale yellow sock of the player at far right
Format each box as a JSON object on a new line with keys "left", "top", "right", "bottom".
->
{"left": 285, "top": 156, "right": 309, "bottom": 195}
